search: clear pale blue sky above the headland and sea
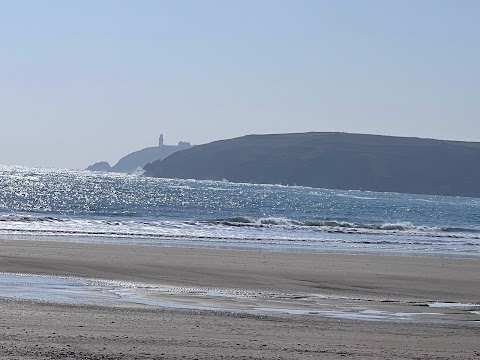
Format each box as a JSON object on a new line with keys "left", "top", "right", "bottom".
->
{"left": 0, "top": 0, "right": 480, "bottom": 169}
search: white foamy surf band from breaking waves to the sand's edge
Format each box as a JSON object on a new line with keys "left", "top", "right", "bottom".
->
{"left": 0, "top": 214, "right": 480, "bottom": 256}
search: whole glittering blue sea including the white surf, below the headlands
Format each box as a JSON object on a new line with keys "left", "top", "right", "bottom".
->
{"left": 0, "top": 166, "right": 480, "bottom": 258}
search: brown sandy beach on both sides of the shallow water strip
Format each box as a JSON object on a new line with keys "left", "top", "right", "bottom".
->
{"left": 0, "top": 240, "right": 480, "bottom": 359}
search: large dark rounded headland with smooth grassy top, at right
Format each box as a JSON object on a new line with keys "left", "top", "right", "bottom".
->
{"left": 145, "top": 133, "right": 480, "bottom": 197}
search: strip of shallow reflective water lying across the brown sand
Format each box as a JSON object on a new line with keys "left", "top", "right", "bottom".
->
{"left": 0, "top": 273, "right": 480, "bottom": 326}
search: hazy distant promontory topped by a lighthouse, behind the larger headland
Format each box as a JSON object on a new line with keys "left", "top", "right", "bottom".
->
{"left": 87, "top": 134, "right": 192, "bottom": 173}
